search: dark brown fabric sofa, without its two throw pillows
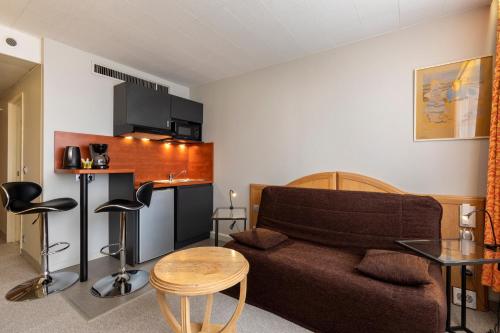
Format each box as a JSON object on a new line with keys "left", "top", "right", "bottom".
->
{"left": 226, "top": 187, "right": 446, "bottom": 333}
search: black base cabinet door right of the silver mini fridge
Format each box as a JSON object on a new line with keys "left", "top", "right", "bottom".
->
{"left": 175, "top": 184, "right": 213, "bottom": 249}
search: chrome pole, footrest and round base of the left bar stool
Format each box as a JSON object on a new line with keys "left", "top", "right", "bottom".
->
{"left": 5, "top": 213, "right": 78, "bottom": 302}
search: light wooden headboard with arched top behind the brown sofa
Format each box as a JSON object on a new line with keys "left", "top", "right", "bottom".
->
{"left": 249, "top": 171, "right": 488, "bottom": 311}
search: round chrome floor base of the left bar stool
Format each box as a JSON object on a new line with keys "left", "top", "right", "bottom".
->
{"left": 5, "top": 272, "right": 78, "bottom": 302}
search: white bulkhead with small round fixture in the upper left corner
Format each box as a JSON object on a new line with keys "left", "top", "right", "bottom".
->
{"left": 0, "top": 25, "right": 42, "bottom": 63}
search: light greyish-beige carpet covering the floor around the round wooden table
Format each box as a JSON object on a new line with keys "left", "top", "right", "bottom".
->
{"left": 0, "top": 244, "right": 495, "bottom": 333}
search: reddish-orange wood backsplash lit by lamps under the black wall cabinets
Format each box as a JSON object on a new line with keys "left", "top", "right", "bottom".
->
{"left": 54, "top": 131, "right": 214, "bottom": 183}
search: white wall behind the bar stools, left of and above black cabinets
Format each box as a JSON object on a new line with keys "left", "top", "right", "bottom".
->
{"left": 43, "top": 39, "right": 189, "bottom": 270}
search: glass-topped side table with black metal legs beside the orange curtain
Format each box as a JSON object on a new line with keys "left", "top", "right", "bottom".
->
{"left": 396, "top": 239, "right": 500, "bottom": 333}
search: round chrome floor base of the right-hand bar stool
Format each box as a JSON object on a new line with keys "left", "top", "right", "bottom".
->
{"left": 90, "top": 270, "right": 149, "bottom": 298}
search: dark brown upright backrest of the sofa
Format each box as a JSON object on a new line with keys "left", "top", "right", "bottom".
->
{"left": 257, "top": 186, "right": 442, "bottom": 250}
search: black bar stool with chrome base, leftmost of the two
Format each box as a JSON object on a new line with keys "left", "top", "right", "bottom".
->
{"left": 0, "top": 182, "right": 78, "bottom": 301}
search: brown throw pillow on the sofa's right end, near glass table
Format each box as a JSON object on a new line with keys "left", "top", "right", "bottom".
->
{"left": 356, "top": 250, "right": 431, "bottom": 286}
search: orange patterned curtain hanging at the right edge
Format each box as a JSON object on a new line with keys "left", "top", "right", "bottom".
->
{"left": 482, "top": 1, "right": 500, "bottom": 292}
